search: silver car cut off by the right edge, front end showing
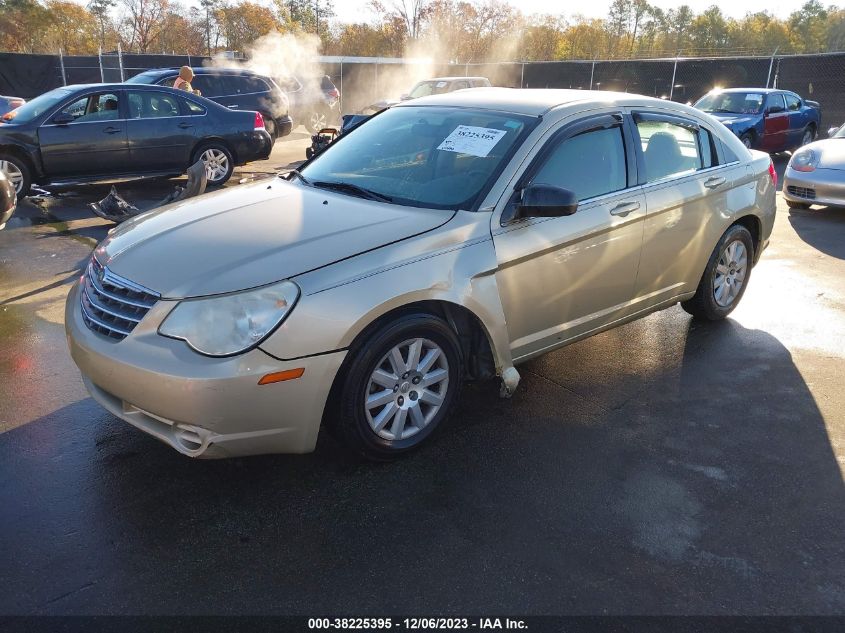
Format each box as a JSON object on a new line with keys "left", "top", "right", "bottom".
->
{"left": 783, "top": 126, "right": 845, "bottom": 209}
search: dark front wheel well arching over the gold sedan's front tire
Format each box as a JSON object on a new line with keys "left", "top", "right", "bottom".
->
{"left": 349, "top": 301, "right": 496, "bottom": 380}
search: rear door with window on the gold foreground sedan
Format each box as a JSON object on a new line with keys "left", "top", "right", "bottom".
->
{"left": 633, "top": 110, "right": 745, "bottom": 308}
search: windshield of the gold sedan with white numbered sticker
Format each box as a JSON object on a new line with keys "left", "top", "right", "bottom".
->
{"left": 302, "top": 106, "right": 537, "bottom": 209}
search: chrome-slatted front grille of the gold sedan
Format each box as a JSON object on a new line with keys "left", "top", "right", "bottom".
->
{"left": 79, "top": 257, "right": 160, "bottom": 341}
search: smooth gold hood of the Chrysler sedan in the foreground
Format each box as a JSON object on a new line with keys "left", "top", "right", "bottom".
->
{"left": 96, "top": 178, "right": 454, "bottom": 298}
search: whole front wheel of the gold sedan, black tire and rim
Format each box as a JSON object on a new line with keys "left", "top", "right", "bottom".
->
{"left": 332, "top": 313, "right": 463, "bottom": 461}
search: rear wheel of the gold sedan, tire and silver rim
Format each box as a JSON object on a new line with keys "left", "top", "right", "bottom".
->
{"left": 681, "top": 224, "right": 754, "bottom": 321}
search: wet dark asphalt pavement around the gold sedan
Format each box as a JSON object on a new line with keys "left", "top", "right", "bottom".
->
{"left": 0, "top": 146, "right": 845, "bottom": 616}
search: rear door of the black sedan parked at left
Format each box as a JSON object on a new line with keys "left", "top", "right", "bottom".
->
{"left": 126, "top": 90, "right": 195, "bottom": 172}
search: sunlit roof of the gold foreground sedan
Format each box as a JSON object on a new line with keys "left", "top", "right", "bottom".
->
{"left": 394, "top": 88, "right": 672, "bottom": 116}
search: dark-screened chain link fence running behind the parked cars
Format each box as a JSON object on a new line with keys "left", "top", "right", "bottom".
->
{"left": 0, "top": 51, "right": 845, "bottom": 127}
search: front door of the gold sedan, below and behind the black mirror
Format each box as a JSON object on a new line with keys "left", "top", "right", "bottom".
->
{"left": 493, "top": 114, "right": 646, "bottom": 360}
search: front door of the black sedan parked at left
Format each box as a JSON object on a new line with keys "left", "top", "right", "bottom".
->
{"left": 38, "top": 91, "right": 129, "bottom": 180}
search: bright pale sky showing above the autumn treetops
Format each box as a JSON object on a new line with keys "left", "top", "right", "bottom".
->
{"left": 334, "top": 0, "right": 800, "bottom": 22}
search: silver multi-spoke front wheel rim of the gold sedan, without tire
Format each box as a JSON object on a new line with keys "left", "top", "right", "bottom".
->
{"left": 364, "top": 338, "right": 449, "bottom": 440}
